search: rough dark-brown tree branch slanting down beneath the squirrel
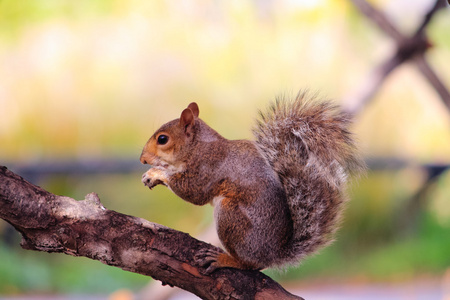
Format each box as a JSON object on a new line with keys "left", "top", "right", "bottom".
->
{"left": 0, "top": 166, "right": 301, "bottom": 299}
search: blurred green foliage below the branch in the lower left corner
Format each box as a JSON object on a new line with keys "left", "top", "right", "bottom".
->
{"left": 0, "top": 244, "right": 149, "bottom": 294}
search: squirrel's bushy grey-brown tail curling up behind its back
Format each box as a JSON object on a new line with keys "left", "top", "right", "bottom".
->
{"left": 253, "top": 92, "right": 364, "bottom": 263}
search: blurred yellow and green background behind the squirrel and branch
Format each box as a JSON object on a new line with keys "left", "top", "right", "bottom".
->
{"left": 0, "top": 0, "right": 450, "bottom": 299}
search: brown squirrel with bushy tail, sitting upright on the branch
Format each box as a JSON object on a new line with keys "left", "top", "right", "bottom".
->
{"left": 140, "top": 92, "right": 364, "bottom": 272}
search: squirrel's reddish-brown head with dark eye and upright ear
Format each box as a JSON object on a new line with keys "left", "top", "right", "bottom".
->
{"left": 140, "top": 102, "right": 199, "bottom": 167}
